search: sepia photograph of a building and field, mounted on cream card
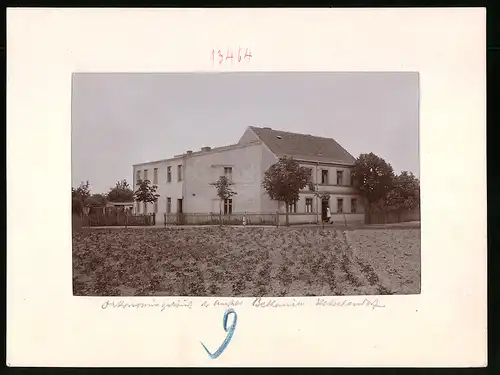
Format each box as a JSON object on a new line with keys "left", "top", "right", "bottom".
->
{"left": 71, "top": 72, "right": 421, "bottom": 297}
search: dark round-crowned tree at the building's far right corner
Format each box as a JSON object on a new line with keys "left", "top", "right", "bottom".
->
{"left": 351, "top": 152, "right": 394, "bottom": 220}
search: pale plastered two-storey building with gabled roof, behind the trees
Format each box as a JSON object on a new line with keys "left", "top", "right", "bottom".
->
{"left": 133, "top": 126, "right": 364, "bottom": 223}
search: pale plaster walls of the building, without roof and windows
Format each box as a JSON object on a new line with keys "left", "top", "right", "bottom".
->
{"left": 133, "top": 142, "right": 364, "bottom": 222}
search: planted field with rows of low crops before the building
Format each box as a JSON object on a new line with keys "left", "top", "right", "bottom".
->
{"left": 72, "top": 227, "right": 420, "bottom": 297}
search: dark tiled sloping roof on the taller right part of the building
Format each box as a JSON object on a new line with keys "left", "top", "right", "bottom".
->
{"left": 250, "top": 126, "right": 356, "bottom": 165}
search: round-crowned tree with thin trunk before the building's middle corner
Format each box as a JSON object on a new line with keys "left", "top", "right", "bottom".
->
{"left": 262, "top": 156, "right": 311, "bottom": 226}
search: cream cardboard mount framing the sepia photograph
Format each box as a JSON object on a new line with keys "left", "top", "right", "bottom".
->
{"left": 7, "top": 8, "right": 487, "bottom": 367}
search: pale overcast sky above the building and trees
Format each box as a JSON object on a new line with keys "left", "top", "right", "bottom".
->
{"left": 72, "top": 72, "right": 420, "bottom": 193}
